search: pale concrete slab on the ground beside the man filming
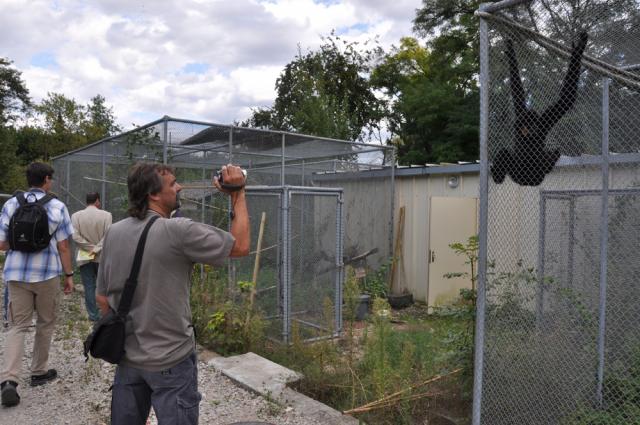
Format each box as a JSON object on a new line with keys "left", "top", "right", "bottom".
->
{"left": 208, "top": 353, "right": 362, "bottom": 425}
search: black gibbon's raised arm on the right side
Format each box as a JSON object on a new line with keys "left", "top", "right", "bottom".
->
{"left": 542, "top": 32, "right": 589, "bottom": 131}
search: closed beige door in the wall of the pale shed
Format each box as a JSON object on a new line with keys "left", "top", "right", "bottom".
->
{"left": 427, "top": 196, "right": 478, "bottom": 307}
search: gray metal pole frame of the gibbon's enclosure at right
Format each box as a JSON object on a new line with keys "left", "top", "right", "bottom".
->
{"left": 472, "top": 0, "right": 640, "bottom": 425}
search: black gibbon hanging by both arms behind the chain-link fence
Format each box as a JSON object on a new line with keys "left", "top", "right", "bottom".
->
{"left": 491, "top": 32, "right": 588, "bottom": 186}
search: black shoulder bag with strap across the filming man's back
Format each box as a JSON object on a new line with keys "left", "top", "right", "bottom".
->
{"left": 84, "top": 215, "right": 159, "bottom": 364}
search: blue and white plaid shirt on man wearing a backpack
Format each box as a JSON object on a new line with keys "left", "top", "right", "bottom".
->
{"left": 0, "top": 189, "right": 73, "bottom": 282}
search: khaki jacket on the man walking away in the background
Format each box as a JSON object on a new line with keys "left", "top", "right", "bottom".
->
{"left": 71, "top": 205, "right": 113, "bottom": 266}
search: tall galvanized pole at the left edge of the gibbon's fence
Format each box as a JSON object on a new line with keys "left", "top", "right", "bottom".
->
{"left": 472, "top": 7, "right": 489, "bottom": 425}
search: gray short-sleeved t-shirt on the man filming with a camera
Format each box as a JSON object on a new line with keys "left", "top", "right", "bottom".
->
{"left": 97, "top": 211, "right": 235, "bottom": 371}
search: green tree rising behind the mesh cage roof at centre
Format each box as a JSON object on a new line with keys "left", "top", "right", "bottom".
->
{"left": 248, "top": 35, "right": 382, "bottom": 140}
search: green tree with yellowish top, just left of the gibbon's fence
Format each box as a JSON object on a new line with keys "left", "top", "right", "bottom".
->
{"left": 371, "top": 37, "right": 479, "bottom": 164}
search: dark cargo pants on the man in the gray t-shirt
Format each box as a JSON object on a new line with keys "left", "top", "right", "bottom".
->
{"left": 111, "top": 353, "right": 201, "bottom": 425}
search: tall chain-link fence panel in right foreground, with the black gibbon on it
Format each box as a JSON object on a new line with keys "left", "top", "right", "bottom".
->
{"left": 474, "top": 0, "right": 640, "bottom": 424}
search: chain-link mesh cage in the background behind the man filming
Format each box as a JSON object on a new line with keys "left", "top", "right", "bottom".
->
{"left": 53, "top": 117, "right": 394, "bottom": 341}
